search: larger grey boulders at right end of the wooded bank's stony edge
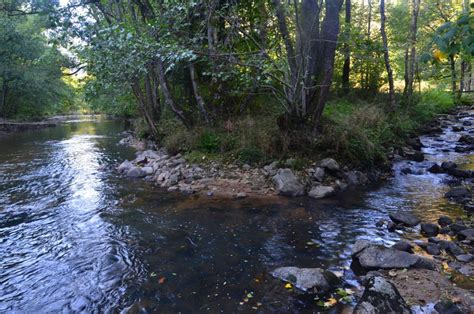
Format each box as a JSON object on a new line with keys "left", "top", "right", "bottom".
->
{"left": 270, "top": 158, "right": 369, "bottom": 199}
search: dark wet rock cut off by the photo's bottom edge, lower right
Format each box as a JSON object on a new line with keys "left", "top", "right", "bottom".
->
{"left": 354, "top": 276, "right": 411, "bottom": 314}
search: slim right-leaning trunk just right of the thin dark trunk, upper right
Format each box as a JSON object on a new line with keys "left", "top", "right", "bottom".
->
{"left": 405, "top": 0, "right": 420, "bottom": 104}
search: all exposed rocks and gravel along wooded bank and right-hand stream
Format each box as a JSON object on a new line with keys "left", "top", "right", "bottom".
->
{"left": 117, "top": 108, "right": 474, "bottom": 313}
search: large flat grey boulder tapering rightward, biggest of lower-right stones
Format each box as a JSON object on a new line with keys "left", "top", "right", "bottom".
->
{"left": 352, "top": 240, "right": 436, "bottom": 271}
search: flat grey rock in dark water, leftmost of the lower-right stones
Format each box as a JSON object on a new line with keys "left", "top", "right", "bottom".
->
{"left": 272, "top": 267, "right": 341, "bottom": 293}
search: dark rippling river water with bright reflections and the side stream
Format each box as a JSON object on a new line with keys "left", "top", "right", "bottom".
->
{"left": 0, "top": 117, "right": 474, "bottom": 313}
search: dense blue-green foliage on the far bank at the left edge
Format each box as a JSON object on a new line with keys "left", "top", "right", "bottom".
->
{"left": 0, "top": 12, "right": 75, "bottom": 119}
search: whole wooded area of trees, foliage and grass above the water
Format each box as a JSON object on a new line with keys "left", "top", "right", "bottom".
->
{"left": 0, "top": 0, "right": 474, "bottom": 167}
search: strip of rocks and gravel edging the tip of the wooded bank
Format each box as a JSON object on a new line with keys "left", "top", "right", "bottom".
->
{"left": 117, "top": 142, "right": 369, "bottom": 199}
